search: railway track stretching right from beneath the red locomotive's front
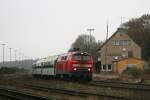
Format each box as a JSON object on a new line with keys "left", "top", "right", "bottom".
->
{"left": 90, "top": 81, "right": 150, "bottom": 92}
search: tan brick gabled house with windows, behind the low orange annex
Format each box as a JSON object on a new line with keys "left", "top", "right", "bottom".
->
{"left": 98, "top": 28, "right": 141, "bottom": 71}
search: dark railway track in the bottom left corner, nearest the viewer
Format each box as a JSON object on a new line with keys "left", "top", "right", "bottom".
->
{"left": 0, "top": 87, "right": 56, "bottom": 100}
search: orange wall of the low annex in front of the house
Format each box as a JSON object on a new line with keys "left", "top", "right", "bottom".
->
{"left": 113, "top": 58, "right": 144, "bottom": 74}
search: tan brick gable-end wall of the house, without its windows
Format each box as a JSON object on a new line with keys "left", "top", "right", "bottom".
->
{"left": 100, "top": 31, "right": 141, "bottom": 71}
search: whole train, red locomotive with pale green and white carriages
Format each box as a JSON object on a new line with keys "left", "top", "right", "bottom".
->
{"left": 32, "top": 51, "right": 93, "bottom": 81}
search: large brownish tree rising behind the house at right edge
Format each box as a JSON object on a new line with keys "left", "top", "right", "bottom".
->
{"left": 122, "top": 14, "right": 150, "bottom": 60}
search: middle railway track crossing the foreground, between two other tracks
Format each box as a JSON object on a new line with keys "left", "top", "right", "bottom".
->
{"left": 27, "top": 84, "right": 143, "bottom": 100}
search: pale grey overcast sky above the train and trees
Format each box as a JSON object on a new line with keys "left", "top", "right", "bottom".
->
{"left": 0, "top": 0, "right": 150, "bottom": 61}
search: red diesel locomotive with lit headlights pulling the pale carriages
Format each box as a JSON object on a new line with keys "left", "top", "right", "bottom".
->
{"left": 56, "top": 52, "right": 93, "bottom": 79}
